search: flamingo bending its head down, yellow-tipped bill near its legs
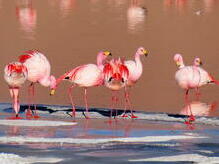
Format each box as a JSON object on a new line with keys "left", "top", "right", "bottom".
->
{"left": 19, "top": 50, "right": 56, "bottom": 118}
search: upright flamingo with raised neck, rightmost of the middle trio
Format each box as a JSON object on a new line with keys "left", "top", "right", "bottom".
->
{"left": 123, "top": 47, "right": 148, "bottom": 118}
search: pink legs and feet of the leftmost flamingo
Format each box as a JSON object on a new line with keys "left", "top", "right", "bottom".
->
{"left": 10, "top": 88, "right": 22, "bottom": 119}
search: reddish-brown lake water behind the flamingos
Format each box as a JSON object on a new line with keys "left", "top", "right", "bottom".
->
{"left": 0, "top": 0, "right": 219, "bottom": 115}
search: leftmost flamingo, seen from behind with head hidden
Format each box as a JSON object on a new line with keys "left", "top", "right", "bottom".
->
{"left": 4, "top": 62, "right": 28, "bottom": 119}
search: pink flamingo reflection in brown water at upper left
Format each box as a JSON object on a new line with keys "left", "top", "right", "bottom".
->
{"left": 16, "top": 0, "right": 37, "bottom": 39}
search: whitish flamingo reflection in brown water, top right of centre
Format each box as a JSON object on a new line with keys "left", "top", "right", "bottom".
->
{"left": 127, "top": 0, "right": 147, "bottom": 32}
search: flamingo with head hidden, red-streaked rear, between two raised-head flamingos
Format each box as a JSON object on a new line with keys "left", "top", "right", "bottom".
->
{"left": 103, "top": 58, "right": 129, "bottom": 120}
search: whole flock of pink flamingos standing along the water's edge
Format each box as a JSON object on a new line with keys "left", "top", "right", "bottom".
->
{"left": 4, "top": 47, "right": 219, "bottom": 123}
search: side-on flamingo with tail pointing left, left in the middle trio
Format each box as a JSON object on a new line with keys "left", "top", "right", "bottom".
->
{"left": 50, "top": 51, "right": 111, "bottom": 119}
